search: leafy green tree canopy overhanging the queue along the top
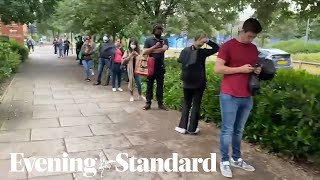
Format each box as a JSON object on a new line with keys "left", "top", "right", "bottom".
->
{"left": 33, "top": 0, "right": 320, "bottom": 40}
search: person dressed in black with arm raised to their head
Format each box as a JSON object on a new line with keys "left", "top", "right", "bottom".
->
{"left": 175, "top": 33, "right": 219, "bottom": 134}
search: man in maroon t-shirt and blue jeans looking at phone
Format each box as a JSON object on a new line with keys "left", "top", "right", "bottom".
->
{"left": 215, "top": 18, "right": 262, "bottom": 177}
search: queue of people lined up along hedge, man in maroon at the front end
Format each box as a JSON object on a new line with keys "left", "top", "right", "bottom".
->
{"left": 77, "top": 18, "right": 263, "bottom": 177}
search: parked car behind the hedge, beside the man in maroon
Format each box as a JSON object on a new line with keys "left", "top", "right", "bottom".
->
{"left": 258, "top": 48, "right": 293, "bottom": 69}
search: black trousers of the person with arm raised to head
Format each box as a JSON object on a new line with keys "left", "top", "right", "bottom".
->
{"left": 179, "top": 88, "right": 205, "bottom": 132}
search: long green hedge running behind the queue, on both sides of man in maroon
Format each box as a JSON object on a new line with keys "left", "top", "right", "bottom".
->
{"left": 143, "top": 59, "right": 320, "bottom": 166}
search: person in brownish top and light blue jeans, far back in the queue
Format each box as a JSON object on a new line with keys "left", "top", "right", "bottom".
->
{"left": 81, "top": 36, "right": 95, "bottom": 82}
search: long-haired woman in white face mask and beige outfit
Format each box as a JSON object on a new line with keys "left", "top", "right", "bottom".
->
{"left": 122, "top": 38, "right": 142, "bottom": 102}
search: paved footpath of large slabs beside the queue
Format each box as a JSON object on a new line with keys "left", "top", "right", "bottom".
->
{"left": 0, "top": 47, "right": 314, "bottom": 180}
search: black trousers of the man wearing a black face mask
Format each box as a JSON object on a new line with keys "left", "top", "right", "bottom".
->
{"left": 146, "top": 73, "right": 164, "bottom": 105}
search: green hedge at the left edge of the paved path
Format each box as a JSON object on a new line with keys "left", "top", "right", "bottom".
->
{"left": 0, "top": 41, "right": 28, "bottom": 80}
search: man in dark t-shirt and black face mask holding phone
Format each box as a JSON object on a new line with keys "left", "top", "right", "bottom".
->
{"left": 143, "top": 25, "right": 169, "bottom": 110}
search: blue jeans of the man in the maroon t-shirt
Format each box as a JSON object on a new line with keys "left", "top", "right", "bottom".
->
{"left": 220, "top": 93, "right": 253, "bottom": 161}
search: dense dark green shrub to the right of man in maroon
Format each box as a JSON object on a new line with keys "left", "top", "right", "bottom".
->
{"left": 245, "top": 70, "right": 320, "bottom": 162}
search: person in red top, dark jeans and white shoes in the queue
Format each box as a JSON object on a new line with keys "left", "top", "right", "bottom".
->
{"left": 112, "top": 39, "right": 123, "bottom": 92}
